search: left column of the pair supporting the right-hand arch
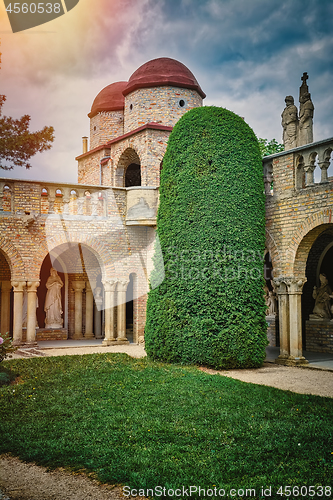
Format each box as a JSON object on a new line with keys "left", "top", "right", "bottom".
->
{"left": 273, "top": 279, "right": 289, "bottom": 364}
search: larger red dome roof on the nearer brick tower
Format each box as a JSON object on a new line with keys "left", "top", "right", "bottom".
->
{"left": 123, "top": 57, "right": 206, "bottom": 99}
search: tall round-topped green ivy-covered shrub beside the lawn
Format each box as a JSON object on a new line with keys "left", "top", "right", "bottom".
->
{"left": 145, "top": 107, "right": 267, "bottom": 368}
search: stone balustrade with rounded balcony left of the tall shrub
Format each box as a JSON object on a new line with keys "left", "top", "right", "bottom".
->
{"left": 0, "top": 178, "right": 158, "bottom": 226}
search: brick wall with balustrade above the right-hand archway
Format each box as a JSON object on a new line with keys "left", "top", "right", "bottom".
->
{"left": 264, "top": 139, "right": 333, "bottom": 277}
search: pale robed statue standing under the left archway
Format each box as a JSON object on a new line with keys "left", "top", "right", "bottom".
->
{"left": 44, "top": 267, "right": 64, "bottom": 328}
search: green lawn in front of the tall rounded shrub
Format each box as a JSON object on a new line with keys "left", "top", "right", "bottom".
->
{"left": 0, "top": 354, "right": 333, "bottom": 499}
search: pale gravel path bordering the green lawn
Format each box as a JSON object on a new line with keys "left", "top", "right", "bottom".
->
{"left": 0, "top": 345, "right": 333, "bottom": 500}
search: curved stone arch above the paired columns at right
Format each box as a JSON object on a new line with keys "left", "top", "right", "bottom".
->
{"left": 286, "top": 209, "right": 333, "bottom": 278}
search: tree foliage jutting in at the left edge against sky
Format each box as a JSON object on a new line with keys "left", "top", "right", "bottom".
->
{"left": 0, "top": 95, "right": 54, "bottom": 170}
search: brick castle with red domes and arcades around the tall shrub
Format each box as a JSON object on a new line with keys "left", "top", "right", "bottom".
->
{"left": 0, "top": 58, "right": 333, "bottom": 364}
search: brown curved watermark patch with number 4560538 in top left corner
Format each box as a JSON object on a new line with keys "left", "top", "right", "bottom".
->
{"left": 4, "top": 0, "right": 80, "bottom": 33}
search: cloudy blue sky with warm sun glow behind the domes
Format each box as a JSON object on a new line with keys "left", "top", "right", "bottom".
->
{"left": 0, "top": 0, "right": 333, "bottom": 182}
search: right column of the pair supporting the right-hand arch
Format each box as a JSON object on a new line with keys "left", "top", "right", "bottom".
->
{"left": 286, "top": 278, "right": 308, "bottom": 365}
